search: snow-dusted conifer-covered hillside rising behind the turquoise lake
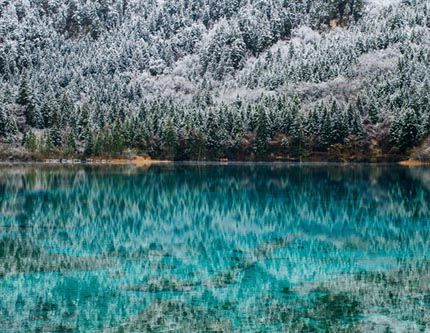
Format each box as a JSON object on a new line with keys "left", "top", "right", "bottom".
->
{"left": 0, "top": 0, "right": 430, "bottom": 161}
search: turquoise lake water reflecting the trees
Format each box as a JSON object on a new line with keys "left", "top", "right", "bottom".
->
{"left": 0, "top": 164, "right": 430, "bottom": 332}
